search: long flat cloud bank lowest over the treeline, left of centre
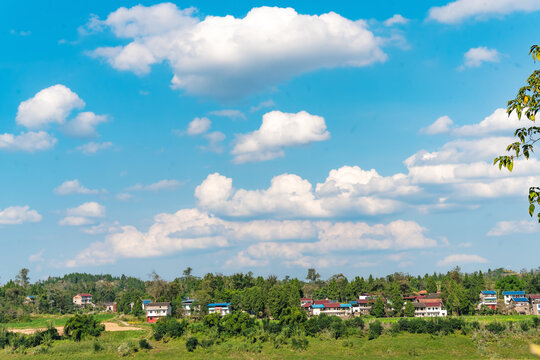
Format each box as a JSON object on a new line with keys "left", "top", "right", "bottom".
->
{"left": 67, "top": 209, "right": 436, "bottom": 267}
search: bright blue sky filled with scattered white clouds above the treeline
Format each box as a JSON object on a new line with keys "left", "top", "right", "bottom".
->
{"left": 0, "top": 0, "right": 540, "bottom": 283}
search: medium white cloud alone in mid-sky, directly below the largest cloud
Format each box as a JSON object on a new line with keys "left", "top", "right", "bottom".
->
{"left": 231, "top": 111, "right": 330, "bottom": 163}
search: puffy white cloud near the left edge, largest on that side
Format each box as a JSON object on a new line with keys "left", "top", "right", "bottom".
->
{"left": 16, "top": 84, "right": 85, "bottom": 129}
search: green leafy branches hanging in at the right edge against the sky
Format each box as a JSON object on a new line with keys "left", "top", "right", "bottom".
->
{"left": 493, "top": 45, "right": 540, "bottom": 222}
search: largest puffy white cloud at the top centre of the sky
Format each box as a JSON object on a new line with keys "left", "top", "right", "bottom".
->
{"left": 90, "top": 3, "right": 386, "bottom": 98}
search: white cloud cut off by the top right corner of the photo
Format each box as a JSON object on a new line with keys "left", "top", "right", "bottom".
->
{"left": 428, "top": 0, "right": 540, "bottom": 24}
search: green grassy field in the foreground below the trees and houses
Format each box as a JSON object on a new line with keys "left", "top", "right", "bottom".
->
{"left": 0, "top": 314, "right": 540, "bottom": 360}
